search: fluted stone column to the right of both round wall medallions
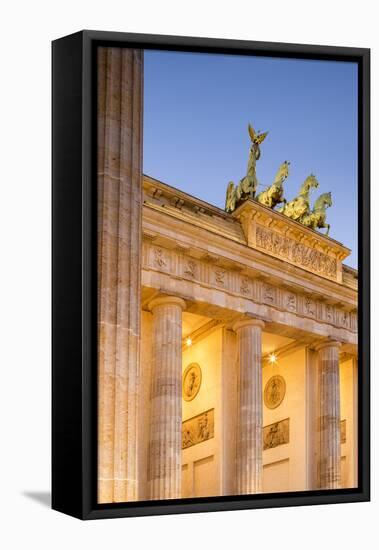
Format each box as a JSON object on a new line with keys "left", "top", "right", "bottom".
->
{"left": 316, "top": 341, "right": 341, "bottom": 489}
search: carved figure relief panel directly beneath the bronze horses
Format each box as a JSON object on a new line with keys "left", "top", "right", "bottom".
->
{"left": 256, "top": 225, "right": 337, "bottom": 279}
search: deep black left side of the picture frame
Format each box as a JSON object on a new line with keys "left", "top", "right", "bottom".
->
{"left": 52, "top": 32, "right": 83, "bottom": 518}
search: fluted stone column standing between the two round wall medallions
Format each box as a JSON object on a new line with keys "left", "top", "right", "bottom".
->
{"left": 233, "top": 319, "right": 264, "bottom": 495}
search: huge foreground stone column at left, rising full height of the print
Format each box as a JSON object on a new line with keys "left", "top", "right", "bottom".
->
{"left": 97, "top": 48, "right": 143, "bottom": 503}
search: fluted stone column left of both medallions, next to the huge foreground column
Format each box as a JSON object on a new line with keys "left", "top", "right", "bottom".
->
{"left": 149, "top": 296, "right": 185, "bottom": 500}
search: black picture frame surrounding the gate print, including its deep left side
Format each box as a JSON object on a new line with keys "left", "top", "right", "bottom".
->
{"left": 52, "top": 30, "right": 370, "bottom": 519}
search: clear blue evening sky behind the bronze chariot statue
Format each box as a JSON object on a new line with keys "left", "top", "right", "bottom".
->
{"left": 143, "top": 50, "right": 358, "bottom": 267}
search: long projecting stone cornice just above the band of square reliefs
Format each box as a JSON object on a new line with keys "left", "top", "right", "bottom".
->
{"left": 143, "top": 204, "right": 357, "bottom": 311}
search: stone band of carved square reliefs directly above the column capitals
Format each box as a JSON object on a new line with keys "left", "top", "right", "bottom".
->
{"left": 142, "top": 234, "right": 357, "bottom": 341}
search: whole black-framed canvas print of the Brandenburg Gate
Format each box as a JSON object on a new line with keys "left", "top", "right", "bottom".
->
{"left": 52, "top": 31, "right": 370, "bottom": 519}
